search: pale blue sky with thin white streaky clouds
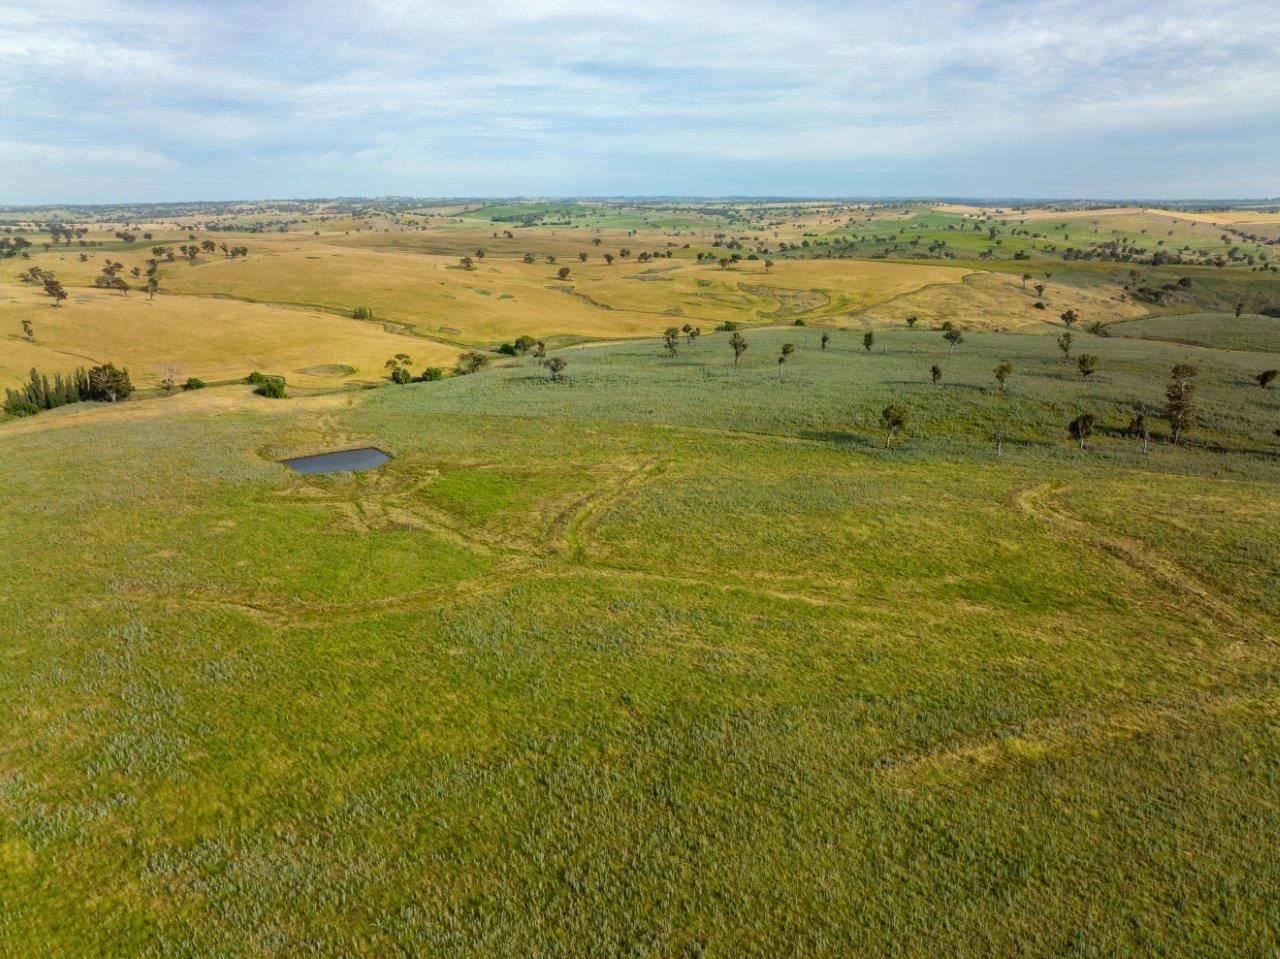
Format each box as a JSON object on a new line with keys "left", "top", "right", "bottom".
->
{"left": 0, "top": 0, "right": 1280, "bottom": 205}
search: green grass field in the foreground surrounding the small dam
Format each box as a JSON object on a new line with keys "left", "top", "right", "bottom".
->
{"left": 0, "top": 312, "right": 1280, "bottom": 959}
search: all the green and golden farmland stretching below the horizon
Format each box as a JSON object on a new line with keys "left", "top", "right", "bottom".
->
{"left": 0, "top": 201, "right": 1280, "bottom": 958}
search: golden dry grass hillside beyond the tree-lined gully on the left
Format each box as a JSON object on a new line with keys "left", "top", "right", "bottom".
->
{"left": 0, "top": 229, "right": 968, "bottom": 387}
